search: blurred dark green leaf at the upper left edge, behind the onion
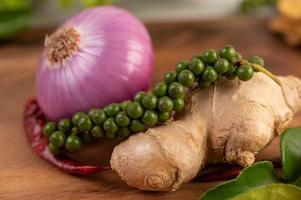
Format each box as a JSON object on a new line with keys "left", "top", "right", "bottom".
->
{"left": 0, "top": 11, "right": 31, "bottom": 40}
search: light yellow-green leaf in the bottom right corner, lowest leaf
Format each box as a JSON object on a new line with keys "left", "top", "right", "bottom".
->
{"left": 231, "top": 184, "right": 301, "bottom": 200}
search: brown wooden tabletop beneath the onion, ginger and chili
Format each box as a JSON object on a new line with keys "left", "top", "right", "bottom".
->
{"left": 0, "top": 17, "right": 301, "bottom": 200}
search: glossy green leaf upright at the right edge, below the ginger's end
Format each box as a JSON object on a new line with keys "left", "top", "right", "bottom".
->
{"left": 280, "top": 128, "right": 301, "bottom": 182}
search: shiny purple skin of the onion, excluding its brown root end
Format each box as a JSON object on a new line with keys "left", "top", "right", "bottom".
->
{"left": 36, "top": 6, "right": 153, "bottom": 121}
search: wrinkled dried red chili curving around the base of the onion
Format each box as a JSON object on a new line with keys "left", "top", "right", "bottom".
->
{"left": 23, "top": 98, "right": 110, "bottom": 175}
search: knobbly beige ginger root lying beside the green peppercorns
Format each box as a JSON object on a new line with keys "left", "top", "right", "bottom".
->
{"left": 110, "top": 72, "right": 301, "bottom": 191}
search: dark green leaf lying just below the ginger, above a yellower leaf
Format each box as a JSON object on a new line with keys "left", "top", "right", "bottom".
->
{"left": 200, "top": 161, "right": 279, "bottom": 200}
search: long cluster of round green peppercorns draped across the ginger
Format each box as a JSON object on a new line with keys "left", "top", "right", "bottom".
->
{"left": 44, "top": 45, "right": 264, "bottom": 155}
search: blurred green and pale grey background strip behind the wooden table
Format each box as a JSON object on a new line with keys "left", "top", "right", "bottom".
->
{"left": 0, "top": 0, "right": 277, "bottom": 40}
